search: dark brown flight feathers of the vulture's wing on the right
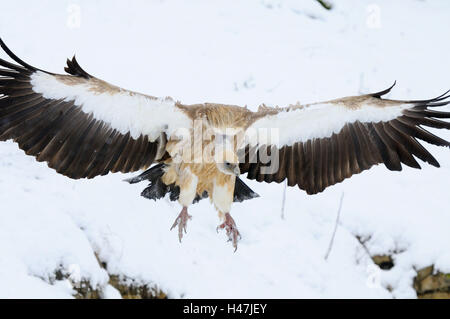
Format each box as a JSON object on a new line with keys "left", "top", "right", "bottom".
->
{"left": 240, "top": 89, "right": 450, "bottom": 198}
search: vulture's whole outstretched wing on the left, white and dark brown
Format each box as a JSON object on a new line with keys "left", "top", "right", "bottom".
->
{"left": 0, "top": 40, "right": 191, "bottom": 178}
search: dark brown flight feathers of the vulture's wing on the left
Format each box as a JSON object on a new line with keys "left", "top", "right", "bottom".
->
{"left": 0, "top": 40, "right": 164, "bottom": 179}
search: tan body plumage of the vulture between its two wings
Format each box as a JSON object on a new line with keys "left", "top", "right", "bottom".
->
{"left": 162, "top": 104, "right": 246, "bottom": 219}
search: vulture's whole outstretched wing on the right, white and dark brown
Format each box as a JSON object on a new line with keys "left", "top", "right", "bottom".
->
{"left": 240, "top": 87, "right": 450, "bottom": 194}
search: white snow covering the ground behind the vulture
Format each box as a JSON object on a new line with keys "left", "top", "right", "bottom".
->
{"left": 0, "top": 0, "right": 450, "bottom": 298}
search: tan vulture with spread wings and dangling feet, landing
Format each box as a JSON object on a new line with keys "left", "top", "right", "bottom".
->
{"left": 0, "top": 40, "right": 450, "bottom": 249}
